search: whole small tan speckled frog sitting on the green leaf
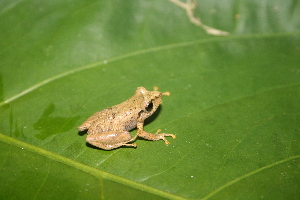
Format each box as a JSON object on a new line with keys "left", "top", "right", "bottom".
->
{"left": 78, "top": 87, "right": 176, "bottom": 150}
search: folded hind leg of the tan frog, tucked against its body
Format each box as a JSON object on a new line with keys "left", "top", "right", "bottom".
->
{"left": 86, "top": 130, "right": 137, "bottom": 150}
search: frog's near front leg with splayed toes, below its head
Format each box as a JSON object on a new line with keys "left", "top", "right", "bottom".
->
{"left": 137, "top": 122, "right": 176, "bottom": 144}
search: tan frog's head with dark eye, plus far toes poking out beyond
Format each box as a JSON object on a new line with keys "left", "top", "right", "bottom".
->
{"left": 135, "top": 87, "right": 170, "bottom": 120}
